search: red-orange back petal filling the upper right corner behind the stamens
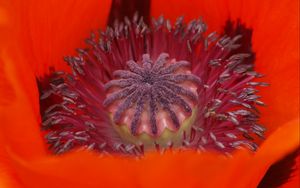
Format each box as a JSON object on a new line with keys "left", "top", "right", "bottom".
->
{"left": 151, "top": 0, "right": 300, "bottom": 132}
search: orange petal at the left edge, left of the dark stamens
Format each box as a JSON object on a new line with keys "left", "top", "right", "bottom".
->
{"left": 0, "top": 48, "right": 45, "bottom": 158}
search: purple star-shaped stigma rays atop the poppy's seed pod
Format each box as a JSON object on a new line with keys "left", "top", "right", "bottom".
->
{"left": 103, "top": 53, "right": 201, "bottom": 136}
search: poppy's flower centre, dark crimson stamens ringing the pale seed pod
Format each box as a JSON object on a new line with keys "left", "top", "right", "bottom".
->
{"left": 41, "top": 15, "right": 268, "bottom": 154}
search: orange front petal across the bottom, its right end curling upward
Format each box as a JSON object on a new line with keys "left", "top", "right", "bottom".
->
{"left": 2, "top": 121, "right": 299, "bottom": 188}
